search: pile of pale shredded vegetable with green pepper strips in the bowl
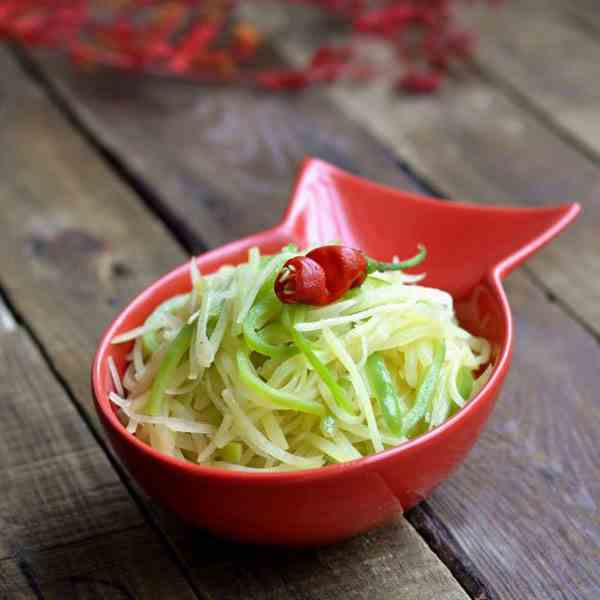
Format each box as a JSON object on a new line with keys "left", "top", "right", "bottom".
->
{"left": 109, "top": 246, "right": 492, "bottom": 472}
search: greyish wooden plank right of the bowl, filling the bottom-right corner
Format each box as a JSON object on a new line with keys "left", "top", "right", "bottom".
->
{"left": 430, "top": 274, "right": 600, "bottom": 600}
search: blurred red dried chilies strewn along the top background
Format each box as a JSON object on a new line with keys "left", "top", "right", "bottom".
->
{"left": 0, "top": 0, "right": 501, "bottom": 94}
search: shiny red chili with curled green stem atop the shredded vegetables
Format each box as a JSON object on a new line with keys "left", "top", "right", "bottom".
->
{"left": 275, "top": 246, "right": 427, "bottom": 306}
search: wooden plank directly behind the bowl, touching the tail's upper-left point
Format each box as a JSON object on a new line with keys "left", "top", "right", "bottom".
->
{"left": 23, "top": 49, "right": 414, "bottom": 249}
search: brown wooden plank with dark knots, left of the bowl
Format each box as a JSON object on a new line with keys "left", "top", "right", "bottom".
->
{"left": 0, "top": 53, "right": 185, "bottom": 408}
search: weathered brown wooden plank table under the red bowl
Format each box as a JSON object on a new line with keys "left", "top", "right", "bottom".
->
{"left": 0, "top": 0, "right": 600, "bottom": 600}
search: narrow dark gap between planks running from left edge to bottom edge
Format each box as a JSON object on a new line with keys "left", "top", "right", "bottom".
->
{"left": 0, "top": 290, "right": 209, "bottom": 600}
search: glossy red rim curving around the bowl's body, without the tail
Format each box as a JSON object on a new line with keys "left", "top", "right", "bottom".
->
{"left": 91, "top": 232, "right": 514, "bottom": 484}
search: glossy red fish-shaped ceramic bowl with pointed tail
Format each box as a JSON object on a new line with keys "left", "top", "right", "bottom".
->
{"left": 92, "top": 160, "right": 580, "bottom": 546}
